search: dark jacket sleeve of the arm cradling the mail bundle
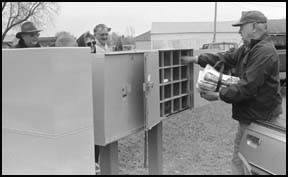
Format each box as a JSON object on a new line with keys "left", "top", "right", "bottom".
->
{"left": 219, "top": 46, "right": 275, "bottom": 103}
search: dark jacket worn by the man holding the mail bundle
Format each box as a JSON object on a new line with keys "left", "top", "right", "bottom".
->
{"left": 198, "top": 35, "right": 282, "bottom": 123}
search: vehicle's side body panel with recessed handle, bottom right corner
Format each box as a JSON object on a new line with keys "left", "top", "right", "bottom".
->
{"left": 239, "top": 123, "right": 286, "bottom": 175}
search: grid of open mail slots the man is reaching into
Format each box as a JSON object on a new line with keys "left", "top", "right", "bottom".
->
{"left": 159, "top": 49, "right": 193, "bottom": 117}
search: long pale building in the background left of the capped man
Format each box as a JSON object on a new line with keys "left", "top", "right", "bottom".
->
{"left": 151, "top": 32, "right": 241, "bottom": 49}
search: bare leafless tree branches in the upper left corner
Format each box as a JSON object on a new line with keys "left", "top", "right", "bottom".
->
{"left": 2, "top": 2, "right": 60, "bottom": 42}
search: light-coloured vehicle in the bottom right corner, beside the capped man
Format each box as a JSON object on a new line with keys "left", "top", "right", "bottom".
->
{"left": 239, "top": 116, "right": 286, "bottom": 175}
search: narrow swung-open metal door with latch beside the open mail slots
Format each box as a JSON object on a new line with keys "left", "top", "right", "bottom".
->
{"left": 143, "top": 52, "right": 160, "bottom": 130}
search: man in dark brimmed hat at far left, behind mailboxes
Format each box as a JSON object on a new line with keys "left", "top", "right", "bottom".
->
{"left": 14, "top": 21, "right": 42, "bottom": 48}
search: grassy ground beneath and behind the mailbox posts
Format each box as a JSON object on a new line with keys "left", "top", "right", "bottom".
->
{"left": 118, "top": 96, "right": 286, "bottom": 175}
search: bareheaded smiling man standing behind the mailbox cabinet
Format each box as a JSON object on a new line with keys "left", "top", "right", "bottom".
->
{"left": 93, "top": 24, "right": 111, "bottom": 53}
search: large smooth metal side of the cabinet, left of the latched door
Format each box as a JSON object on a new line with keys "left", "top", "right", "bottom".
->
{"left": 92, "top": 52, "right": 144, "bottom": 145}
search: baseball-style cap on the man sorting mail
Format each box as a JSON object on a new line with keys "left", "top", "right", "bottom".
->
{"left": 232, "top": 11, "right": 267, "bottom": 26}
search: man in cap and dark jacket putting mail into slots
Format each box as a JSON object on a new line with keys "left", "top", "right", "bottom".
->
{"left": 182, "top": 11, "right": 282, "bottom": 175}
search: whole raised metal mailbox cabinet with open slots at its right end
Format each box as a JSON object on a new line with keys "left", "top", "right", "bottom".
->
{"left": 92, "top": 49, "right": 194, "bottom": 145}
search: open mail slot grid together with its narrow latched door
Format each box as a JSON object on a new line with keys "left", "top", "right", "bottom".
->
{"left": 145, "top": 49, "right": 195, "bottom": 129}
